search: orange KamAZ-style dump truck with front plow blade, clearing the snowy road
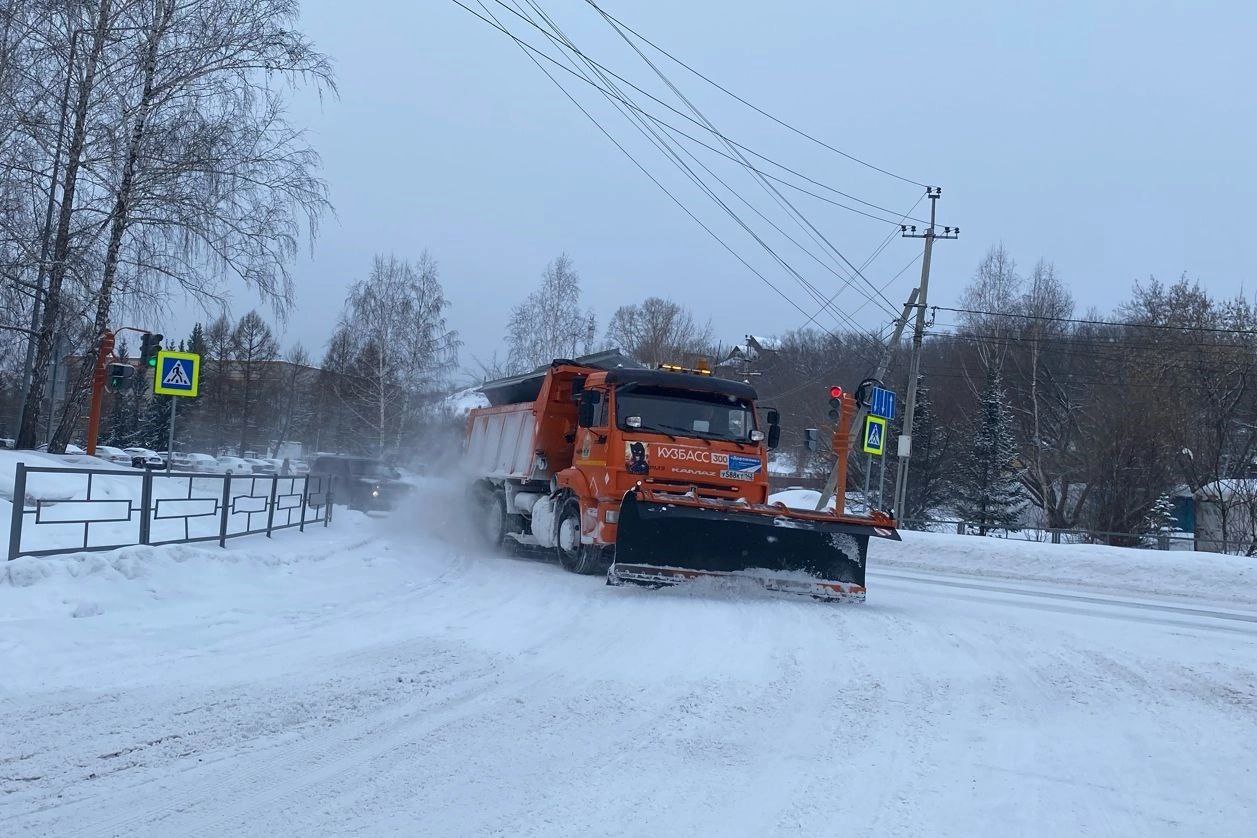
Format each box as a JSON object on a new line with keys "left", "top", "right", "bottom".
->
{"left": 465, "top": 361, "right": 899, "bottom": 599}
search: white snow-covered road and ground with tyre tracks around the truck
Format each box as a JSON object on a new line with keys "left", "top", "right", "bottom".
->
{"left": 7, "top": 481, "right": 1257, "bottom": 835}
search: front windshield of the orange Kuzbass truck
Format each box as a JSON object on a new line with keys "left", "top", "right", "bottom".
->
{"left": 616, "top": 386, "right": 755, "bottom": 442}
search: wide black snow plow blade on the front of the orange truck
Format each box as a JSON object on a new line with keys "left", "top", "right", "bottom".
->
{"left": 607, "top": 490, "right": 899, "bottom": 602}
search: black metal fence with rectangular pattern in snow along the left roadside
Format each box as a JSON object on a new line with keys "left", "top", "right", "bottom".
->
{"left": 9, "top": 462, "right": 334, "bottom": 560}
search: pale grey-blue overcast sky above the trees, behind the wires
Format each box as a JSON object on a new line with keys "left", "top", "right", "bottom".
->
{"left": 157, "top": 0, "right": 1257, "bottom": 376}
